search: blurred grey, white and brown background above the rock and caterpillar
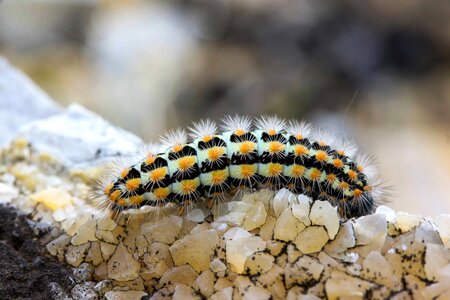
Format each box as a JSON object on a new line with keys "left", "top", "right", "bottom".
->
{"left": 0, "top": 0, "right": 450, "bottom": 216}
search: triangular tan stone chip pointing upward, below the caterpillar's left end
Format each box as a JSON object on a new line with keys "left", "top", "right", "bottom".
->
{"left": 108, "top": 243, "right": 141, "bottom": 281}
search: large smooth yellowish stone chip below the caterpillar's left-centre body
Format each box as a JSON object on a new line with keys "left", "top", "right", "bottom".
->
{"left": 169, "top": 230, "right": 219, "bottom": 272}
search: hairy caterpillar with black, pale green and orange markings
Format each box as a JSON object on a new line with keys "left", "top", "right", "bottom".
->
{"left": 97, "top": 115, "right": 382, "bottom": 218}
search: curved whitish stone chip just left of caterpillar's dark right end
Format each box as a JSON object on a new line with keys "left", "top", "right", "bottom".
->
{"left": 309, "top": 200, "right": 339, "bottom": 240}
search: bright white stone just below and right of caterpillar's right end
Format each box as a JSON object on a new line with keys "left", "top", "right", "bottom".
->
{"left": 353, "top": 214, "right": 387, "bottom": 245}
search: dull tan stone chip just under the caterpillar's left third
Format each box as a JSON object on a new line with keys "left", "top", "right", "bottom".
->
{"left": 141, "top": 216, "right": 183, "bottom": 244}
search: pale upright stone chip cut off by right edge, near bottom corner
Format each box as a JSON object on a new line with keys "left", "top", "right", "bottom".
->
{"left": 425, "top": 244, "right": 450, "bottom": 281}
